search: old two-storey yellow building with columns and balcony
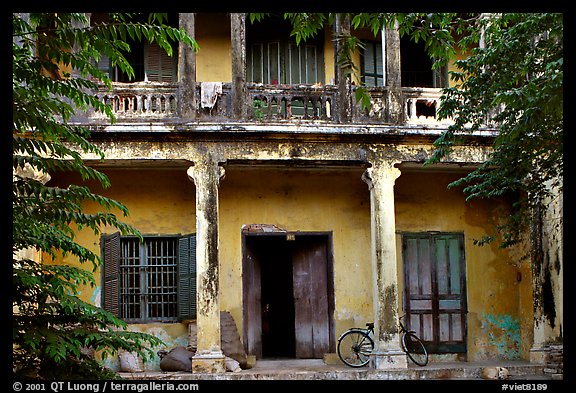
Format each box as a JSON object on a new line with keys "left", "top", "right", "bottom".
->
{"left": 44, "top": 13, "right": 563, "bottom": 372}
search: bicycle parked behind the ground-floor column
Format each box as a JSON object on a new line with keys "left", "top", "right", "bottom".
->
{"left": 337, "top": 315, "right": 428, "bottom": 367}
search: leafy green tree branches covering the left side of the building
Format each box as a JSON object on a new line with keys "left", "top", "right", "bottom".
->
{"left": 12, "top": 13, "right": 197, "bottom": 378}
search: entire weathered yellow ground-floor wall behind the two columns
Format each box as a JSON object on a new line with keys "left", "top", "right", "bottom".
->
{"left": 47, "top": 167, "right": 532, "bottom": 360}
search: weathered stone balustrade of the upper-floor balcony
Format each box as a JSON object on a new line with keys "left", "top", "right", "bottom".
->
{"left": 75, "top": 82, "right": 449, "bottom": 126}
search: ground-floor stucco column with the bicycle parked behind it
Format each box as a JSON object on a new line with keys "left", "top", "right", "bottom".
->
{"left": 362, "top": 162, "right": 408, "bottom": 369}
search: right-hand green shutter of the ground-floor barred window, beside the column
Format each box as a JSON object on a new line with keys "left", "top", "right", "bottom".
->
{"left": 178, "top": 234, "right": 196, "bottom": 320}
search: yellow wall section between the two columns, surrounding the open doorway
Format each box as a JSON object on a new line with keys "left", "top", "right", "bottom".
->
{"left": 220, "top": 169, "right": 372, "bottom": 334}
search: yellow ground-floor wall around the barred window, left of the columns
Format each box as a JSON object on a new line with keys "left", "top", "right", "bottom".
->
{"left": 50, "top": 168, "right": 196, "bottom": 369}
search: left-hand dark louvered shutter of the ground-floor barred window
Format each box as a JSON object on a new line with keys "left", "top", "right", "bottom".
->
{"left": 100, "top": 232, "right": 120, "bottom": 317}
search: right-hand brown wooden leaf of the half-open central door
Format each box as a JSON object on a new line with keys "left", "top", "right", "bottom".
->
{"left": 292, "top": 237, "right": 330, "bottom": 359}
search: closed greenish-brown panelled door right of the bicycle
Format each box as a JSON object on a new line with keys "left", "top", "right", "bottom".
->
{"left": 402, "top": 232, "right": 466, "bottom": 353}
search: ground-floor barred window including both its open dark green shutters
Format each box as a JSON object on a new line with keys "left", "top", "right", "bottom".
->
{"left": 101, "top": 233, "right": 196, "bottom": 323}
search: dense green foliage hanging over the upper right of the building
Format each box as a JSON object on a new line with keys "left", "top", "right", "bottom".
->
{"left": 428, "top": 13, "right": 564, "bottom": 247}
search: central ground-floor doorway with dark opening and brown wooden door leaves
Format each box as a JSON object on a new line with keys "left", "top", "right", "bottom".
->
{"left": 242, "top": 232, "right": 334, "bottom": 359}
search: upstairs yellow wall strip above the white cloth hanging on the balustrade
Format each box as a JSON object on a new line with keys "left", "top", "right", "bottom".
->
{"left": 195, "top": 13, "right": 232, "bottom": 82}
